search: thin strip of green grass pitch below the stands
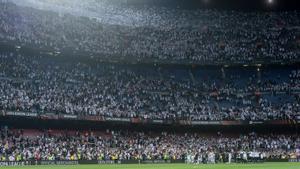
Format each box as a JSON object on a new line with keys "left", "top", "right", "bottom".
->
{"left": 0, "top": 163, "right": 300, "bottom": 169}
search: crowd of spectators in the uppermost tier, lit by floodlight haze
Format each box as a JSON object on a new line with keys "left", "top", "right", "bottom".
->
{"left": 0, "top": 0, "right": 300, "bottom": 63}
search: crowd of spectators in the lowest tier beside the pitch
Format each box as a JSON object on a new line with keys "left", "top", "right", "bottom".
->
{"left": 0, "top": 128, "right": 300, "bottom": 162}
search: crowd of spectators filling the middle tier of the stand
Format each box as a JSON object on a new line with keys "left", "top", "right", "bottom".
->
{"left": 0, "top": 53, "right": 300, "bottom": 121}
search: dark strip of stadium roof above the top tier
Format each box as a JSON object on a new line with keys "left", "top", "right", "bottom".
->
{"left": 126, "top": 0, "right": 300, "bottom": 11}
